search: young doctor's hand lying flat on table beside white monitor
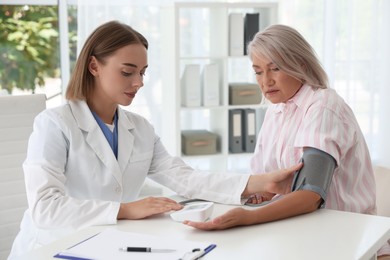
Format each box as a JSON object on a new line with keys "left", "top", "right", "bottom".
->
{"left": 117, "top": 197, "right": 183, "bottom": 219}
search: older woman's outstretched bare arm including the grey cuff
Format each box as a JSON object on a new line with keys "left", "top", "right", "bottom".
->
{"left": 184, "top": 148, "right": 336, "bottom": 230}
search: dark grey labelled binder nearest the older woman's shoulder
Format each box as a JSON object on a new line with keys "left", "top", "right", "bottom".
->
{"left": 242, "top": 108, "right": 256, "bottom": 153}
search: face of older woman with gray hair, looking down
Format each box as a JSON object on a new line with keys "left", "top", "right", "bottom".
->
{"left": 252, "top": 55, "right": 302, "bottom": 104}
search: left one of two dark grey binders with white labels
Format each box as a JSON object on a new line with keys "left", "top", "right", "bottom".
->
{"left": 229, "top": 109, "right": 242, "bottom": 153}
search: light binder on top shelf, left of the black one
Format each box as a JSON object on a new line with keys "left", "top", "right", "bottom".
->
{"left": 229, "top": 13, "right": 245, "bottom": 56}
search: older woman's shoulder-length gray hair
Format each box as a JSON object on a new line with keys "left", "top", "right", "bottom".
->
{"left": 248, "top": 24, "right": 329, "bottom": 88}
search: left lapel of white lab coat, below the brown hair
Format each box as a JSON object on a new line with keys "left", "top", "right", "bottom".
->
{"left": 69, "top": 101, "right": 122, "bottom": 183}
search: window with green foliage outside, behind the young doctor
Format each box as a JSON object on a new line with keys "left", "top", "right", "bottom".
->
{"left": 0, "top": 1, "right": 77, "bottom": 107}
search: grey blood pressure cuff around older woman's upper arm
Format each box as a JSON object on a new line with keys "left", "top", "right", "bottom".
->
{"left": 292, "top": 147, "right": 337, "bottom": 207}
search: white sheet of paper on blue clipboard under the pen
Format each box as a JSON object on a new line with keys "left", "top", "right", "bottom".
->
{"left": 55, "top": 229, "right": 212, "bottom": 260}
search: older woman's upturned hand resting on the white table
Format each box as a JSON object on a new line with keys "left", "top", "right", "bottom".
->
{"left": 183, "top": 208, "right": 254, "bottom": 230}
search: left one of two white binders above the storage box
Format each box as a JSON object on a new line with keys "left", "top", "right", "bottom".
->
{"left": 181, "top": 64, "right": 201, "bottom": 107}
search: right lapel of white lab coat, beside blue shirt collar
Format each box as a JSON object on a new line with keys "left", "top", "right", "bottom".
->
{"left": 118, "top": 108, "right": 134, "bottom": 171}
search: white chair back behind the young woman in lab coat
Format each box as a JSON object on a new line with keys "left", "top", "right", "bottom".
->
{"left": 0, "top": 94, "right": 46, "bottom": 259}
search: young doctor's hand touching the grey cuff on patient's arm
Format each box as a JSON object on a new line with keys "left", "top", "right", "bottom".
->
{"left": 242, "top": 163, "right": 303, "bottom": 197}
